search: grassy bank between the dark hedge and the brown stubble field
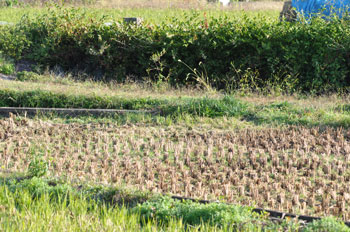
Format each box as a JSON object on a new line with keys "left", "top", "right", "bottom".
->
{"left": 0, "top": 76, "right": 350, "bottom": 128}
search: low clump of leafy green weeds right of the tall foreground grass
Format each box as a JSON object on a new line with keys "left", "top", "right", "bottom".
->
{"left": 134, "top": 197, "right": 264, "bottom": 229}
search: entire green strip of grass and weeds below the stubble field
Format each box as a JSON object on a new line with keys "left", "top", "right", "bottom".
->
{"left": 0, "top": 176, "right": 349, "bottom": 231}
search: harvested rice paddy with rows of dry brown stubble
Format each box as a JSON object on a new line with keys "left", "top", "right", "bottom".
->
{"left": 0, "top": 118, "right": 350, "bottom": 220}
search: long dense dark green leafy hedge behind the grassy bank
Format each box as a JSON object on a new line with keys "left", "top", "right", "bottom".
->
{"left": 0, "top": 7, "right": 350, "bottom": 93}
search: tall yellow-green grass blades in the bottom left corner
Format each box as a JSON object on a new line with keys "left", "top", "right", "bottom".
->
{"left": 0, "top": 183, "right": 174, "bottom": 231}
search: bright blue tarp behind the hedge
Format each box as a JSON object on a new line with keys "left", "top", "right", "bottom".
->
{"left": 292, "top": 0, "right": 350, "bottom": 19}
